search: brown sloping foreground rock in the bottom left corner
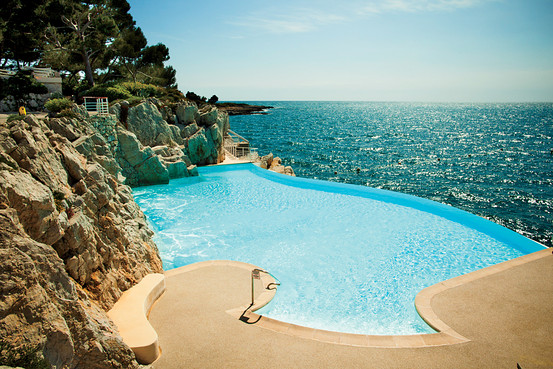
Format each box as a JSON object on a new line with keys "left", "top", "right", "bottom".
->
{"left": 0, "top": 208, "right": 139, "bottom": 368}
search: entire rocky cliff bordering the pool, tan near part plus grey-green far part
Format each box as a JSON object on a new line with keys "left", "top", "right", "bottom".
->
{"left": 0, "top": 101, "right": 228, "bottom": 368}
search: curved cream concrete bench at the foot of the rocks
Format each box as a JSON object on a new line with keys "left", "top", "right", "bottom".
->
{"left": 108, "top": 273, "right": 165, "bottom": 364}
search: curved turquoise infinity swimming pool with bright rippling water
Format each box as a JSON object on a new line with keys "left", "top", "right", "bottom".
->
{"left": 133, "top": 164, "right": 544, "bottom": 335}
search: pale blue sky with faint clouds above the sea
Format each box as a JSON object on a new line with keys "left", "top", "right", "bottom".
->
{"left": 129, "top": 0, "right": 553, "bottom": 102}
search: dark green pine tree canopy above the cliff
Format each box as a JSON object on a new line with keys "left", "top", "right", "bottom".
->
{"left": 0, "top": 0, "right": 176, "bottom": 87}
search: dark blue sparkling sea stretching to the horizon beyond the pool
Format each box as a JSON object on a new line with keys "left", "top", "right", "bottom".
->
{"left": 230, "top": 101, "right": 553, "bottom": 247}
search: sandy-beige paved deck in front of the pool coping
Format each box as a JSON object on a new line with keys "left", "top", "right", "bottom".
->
{"left": 150, "top": 249, "right": 553, "bottom": 369}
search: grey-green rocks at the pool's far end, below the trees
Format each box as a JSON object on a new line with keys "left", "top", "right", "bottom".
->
{"left": 111, "top": 99, "right": 229, "bottom": 186}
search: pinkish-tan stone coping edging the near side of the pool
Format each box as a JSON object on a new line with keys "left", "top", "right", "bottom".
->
{"left": 165, "top": 248, "right": 552, "bottom": 348}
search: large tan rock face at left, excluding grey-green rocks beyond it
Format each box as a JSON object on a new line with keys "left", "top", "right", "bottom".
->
{"left": 0, "top": 116, "right": 162, "bottom": 368}
